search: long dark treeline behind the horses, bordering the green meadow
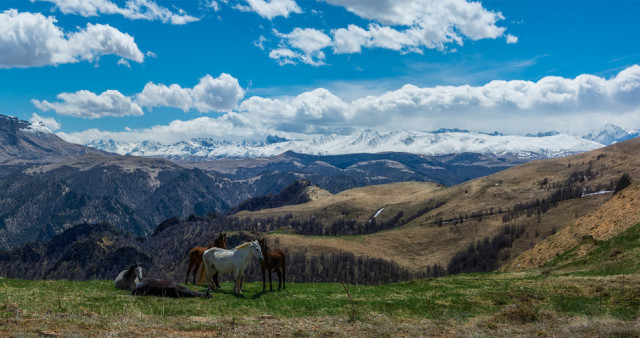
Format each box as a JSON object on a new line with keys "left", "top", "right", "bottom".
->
{"left": 0, "top": 219, "right": 524, "bottom": 285}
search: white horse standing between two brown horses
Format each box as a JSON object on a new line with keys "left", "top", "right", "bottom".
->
{"left": 202, "top": 241, "right": 264, "bottom": 293}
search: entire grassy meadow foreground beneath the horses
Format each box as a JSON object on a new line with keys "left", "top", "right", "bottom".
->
{"left": 0, "top": 271, "right": 640, "bottom": 336}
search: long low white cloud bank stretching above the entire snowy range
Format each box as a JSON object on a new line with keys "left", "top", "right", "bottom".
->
{"left": 56, "top": 65, "right": 640, "bottom": 143}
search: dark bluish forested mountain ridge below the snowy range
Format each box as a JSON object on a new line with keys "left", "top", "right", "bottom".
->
{"left": 0, "top": 116, "right": 522, "bottom": 250}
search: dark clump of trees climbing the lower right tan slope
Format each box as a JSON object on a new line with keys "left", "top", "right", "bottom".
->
{"left": 447, "top": 225, "right": 524, "bottom": 275}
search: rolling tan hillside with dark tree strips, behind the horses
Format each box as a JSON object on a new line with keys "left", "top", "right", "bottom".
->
{"left": 2, "top": 139, "right": 640, "bottom": 284}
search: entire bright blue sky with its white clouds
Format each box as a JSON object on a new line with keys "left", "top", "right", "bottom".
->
{"left": 0, "top": 0, "right": 640, "bottom": 143}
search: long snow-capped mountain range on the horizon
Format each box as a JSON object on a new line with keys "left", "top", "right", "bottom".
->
{"left": 87, "top": 124, "right": 640, "bottom": 161}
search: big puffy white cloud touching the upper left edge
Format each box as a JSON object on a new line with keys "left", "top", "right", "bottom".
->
{"left": 0, "top": 9, "right": 144, "bottom": 68}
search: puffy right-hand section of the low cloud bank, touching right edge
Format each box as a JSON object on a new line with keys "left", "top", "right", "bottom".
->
{"left": 351, "top": 66, "right": 640, "bottom": 133}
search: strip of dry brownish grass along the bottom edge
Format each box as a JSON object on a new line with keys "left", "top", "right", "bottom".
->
{"left": 0, "top": 306, "right": 640, "bottom": 337}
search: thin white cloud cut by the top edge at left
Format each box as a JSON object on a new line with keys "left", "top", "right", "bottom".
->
{"left": 31, "top": 0, "right": 199, "bottom": 25}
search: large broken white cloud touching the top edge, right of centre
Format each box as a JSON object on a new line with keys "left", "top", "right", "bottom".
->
{"left": 270, "top": 0, "right": 518, "bottom": 65}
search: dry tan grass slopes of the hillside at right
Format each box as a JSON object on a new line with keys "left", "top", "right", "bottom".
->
{"left": 238, "top": 139, "right": 640, "bottom": 271}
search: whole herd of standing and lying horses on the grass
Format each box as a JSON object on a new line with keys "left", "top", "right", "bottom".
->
{"left": 115, "top": 233, "right": 287, "bottom": 297}
